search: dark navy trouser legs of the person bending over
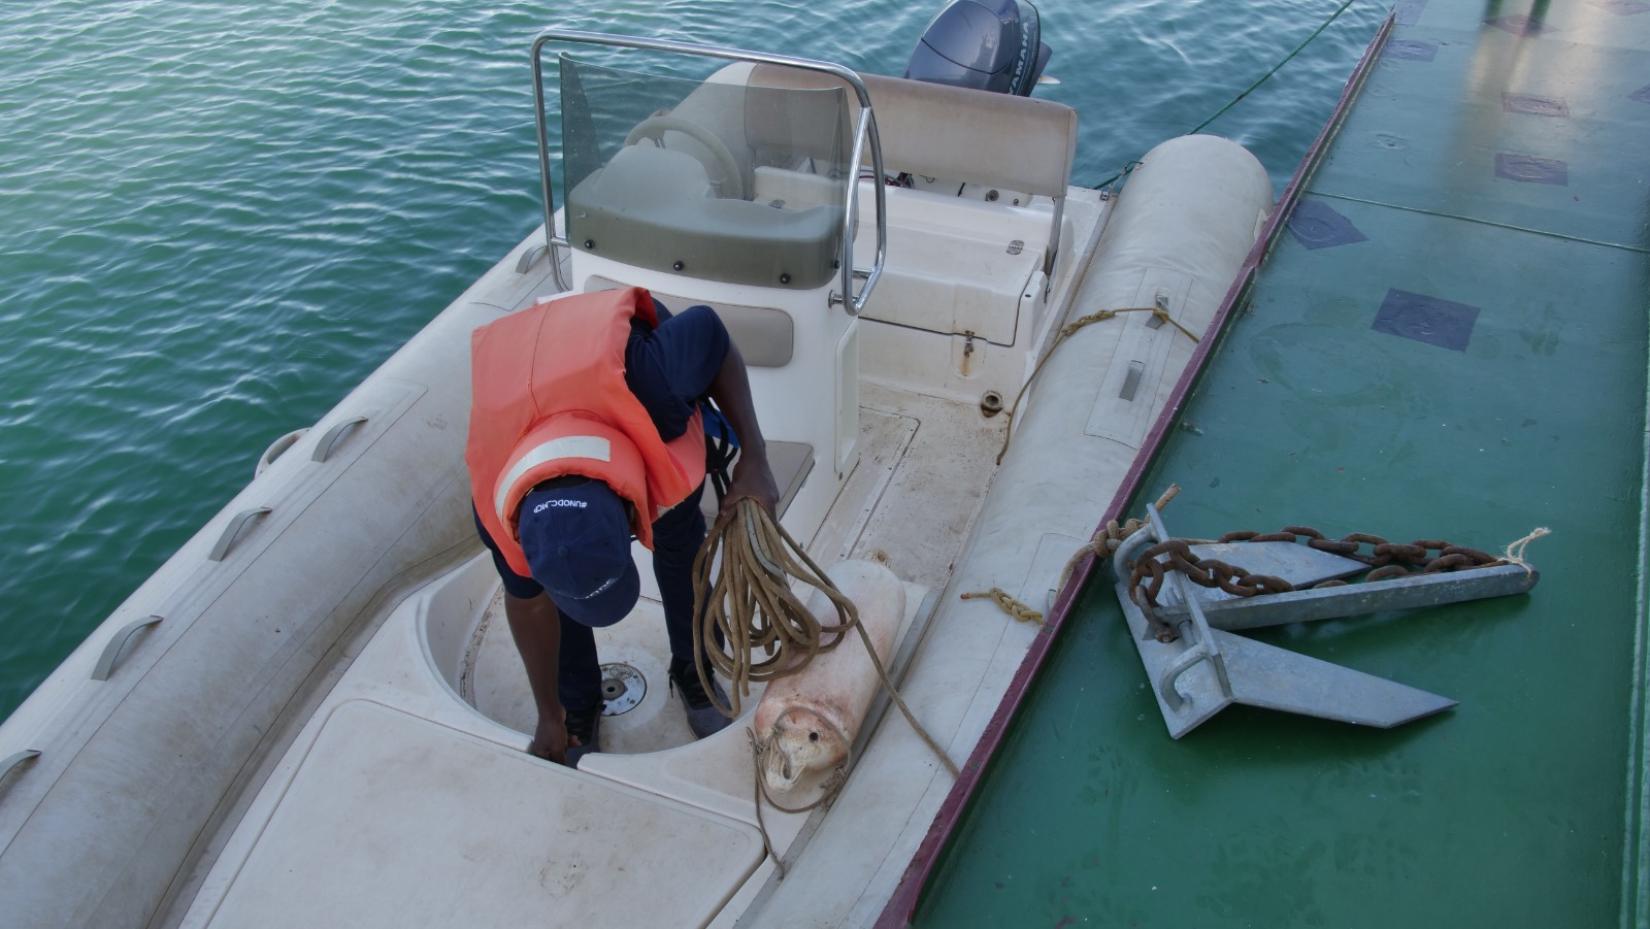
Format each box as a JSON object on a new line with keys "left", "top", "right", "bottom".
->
{"left": 559, "top": 483, "right": 705, "bottom": 713}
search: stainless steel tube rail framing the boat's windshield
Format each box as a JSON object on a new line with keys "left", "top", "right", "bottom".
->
{"left": 531, "top": 30, "right": 888, "bottom": 315}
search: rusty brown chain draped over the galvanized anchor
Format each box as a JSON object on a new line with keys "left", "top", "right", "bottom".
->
{"left": 1129, "top": 526, "right": 1505, "bottom": 642}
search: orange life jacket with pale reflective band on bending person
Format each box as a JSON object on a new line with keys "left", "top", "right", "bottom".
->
{"left": 464, "top": 287, "right": 705, "bottom": 576}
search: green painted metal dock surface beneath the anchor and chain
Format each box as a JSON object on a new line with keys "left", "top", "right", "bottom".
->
{"left": 884, "top": 0, "right": 1650, "bottom": 927}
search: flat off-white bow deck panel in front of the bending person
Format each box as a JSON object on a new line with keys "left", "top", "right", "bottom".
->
{"left": 198, "top": 700, "right": 762, "bottom": 929}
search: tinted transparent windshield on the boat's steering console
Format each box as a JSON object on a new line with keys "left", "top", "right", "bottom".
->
{"left": 561, "top": 54, "right": 855, "bottom": 289}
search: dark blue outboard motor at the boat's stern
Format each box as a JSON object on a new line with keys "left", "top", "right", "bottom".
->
{"left": 906, "top": 0, "right": 1053, "bottom": 97}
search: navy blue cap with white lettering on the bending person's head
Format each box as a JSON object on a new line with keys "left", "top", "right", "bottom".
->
{"left": 516, "top": 480, "right": 642, "bottom": 625}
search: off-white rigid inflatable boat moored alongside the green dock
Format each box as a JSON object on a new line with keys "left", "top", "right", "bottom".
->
{"left": 0, "top": 9, "right": 1272, "bottom": 929}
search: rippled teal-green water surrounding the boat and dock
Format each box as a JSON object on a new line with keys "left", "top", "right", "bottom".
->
{"left": 0, "top": 0, "right": 1386, "bottom": 716}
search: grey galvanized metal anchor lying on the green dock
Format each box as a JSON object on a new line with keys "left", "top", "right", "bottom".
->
{"left": 1112, "top": 505, "right": 1539, "bottom": 739}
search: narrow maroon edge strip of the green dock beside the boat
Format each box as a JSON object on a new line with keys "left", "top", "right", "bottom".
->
{"left": 876, "top": 13, "right": 1393, "bottom": 929}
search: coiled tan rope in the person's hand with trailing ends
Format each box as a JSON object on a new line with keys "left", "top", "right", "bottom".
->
{"left": 693, "top": 498, "right": 959, "bottom": 876}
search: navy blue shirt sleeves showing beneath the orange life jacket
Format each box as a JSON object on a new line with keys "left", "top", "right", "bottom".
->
{"left": 475, "top": 299, "right": 729, "bottom": 599}
